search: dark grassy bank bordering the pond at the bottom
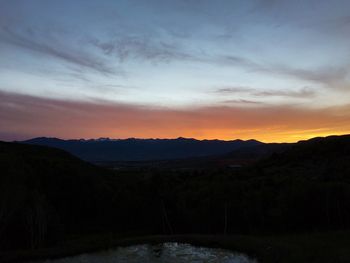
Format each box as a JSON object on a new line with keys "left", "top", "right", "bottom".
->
{"left": 0, "top": 231, "right": 350, "bottom": 263}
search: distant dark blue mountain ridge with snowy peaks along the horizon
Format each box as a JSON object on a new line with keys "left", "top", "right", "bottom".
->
{"left": 22, "top": 137, "right": 263, "bottom": 162}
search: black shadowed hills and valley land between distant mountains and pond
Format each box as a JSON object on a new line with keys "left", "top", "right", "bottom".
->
{"left": 0, "top": 136, "right": 350, "bottom": 262}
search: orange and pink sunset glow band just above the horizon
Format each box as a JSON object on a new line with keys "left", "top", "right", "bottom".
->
{"left": 0, "top": 93, "right": 350, "bottom": 142}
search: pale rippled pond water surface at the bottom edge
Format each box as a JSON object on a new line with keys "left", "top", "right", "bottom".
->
{"left": 37, "top": 243, "right": 257, "bottom": 263}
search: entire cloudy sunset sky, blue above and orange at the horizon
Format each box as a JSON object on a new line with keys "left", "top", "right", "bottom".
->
{"left": 0, "top": 0, "right": 350, "bottom": 142}
